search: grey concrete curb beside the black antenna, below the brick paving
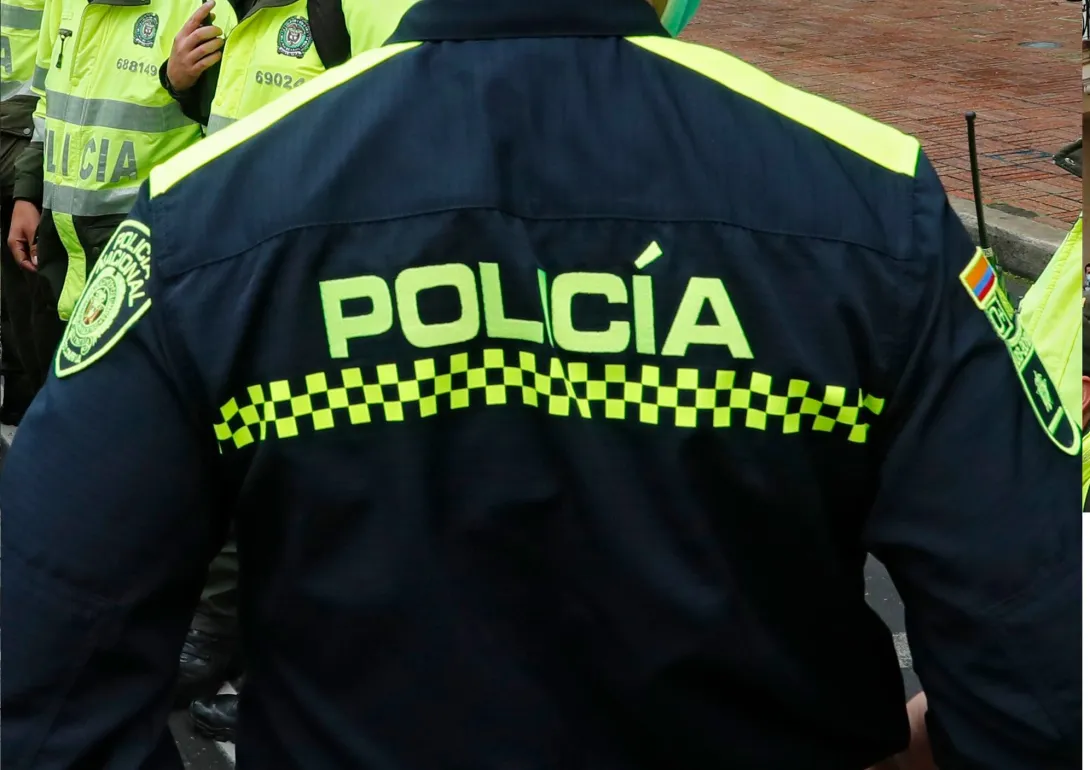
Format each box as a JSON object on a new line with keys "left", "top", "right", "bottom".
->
{"left": 950, "top": 197, "right": 1067, "bottom": 280}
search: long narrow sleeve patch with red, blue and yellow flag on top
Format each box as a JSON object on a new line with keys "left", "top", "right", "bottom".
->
{"left": 960, "top": 249, "right": 1081, "bottom": 455}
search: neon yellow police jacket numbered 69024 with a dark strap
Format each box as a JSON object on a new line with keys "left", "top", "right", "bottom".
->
{"left": 207, "top": 0, "right": 415, "bottom": 134}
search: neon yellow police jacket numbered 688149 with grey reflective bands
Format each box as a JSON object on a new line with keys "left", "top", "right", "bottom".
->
{"left": 34, "top": 0, "right": 233, "bottom": 318}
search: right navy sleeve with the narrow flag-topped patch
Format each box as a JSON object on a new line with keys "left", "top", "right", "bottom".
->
{"left": 865, "top": 152, "right": 1081, "bottom": 770}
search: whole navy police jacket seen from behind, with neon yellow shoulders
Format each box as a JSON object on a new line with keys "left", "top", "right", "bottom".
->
{"left": 0, "top": 0, "right": 1080, "bottom": 770}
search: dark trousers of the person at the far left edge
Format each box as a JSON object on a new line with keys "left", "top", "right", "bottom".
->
{"left": 0, "top": 133, "right": 64, "bottom": 412}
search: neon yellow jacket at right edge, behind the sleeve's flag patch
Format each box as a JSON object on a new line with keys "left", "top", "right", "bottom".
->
{"left": 1018, "top": 216, "right": 1090, "bottom": 502}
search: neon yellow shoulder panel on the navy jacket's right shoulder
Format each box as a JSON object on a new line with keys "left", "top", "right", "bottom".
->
{"left": 628, "top": 37, "right": 920, "bottom": 177}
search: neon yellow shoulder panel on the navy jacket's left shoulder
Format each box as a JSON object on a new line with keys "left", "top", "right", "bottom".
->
{"left": 148, "top": 43, "right": 420, "bottom": 197}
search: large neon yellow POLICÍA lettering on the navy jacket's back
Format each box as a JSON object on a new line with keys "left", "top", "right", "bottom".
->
{"left": 319, "top": 257, "right": 753, "bottom": 359}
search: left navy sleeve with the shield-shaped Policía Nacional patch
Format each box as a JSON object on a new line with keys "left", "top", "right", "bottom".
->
{"left": 0, "top": 184, "right": 226, "bottom": 769}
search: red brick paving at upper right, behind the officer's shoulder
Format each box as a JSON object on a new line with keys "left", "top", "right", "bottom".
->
{"left": 685, "top": 0, "right": 1082, "bottom": 229}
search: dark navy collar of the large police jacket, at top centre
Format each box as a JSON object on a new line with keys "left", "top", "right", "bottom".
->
{"left": 388, "top": 0, "right": 667, "bottom": 44}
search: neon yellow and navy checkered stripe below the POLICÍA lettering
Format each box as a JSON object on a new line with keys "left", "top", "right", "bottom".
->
{"left": 215, "top": 348, "right": 885, "bottom": 449}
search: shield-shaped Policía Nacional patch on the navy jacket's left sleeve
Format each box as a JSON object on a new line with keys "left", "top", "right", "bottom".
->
{"left": 53, "top": 219, "right": 152, "bottom": 377}
